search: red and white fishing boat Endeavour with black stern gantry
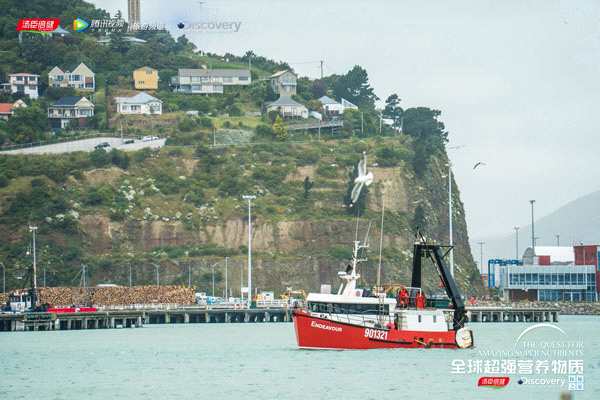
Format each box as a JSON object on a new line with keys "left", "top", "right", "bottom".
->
{"left": 293, "top": 238, "right": 473, "bottom": 349}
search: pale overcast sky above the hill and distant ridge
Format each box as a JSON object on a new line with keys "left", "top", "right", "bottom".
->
{"left": 93, "top": 0, "right": 600, "bottom": 244}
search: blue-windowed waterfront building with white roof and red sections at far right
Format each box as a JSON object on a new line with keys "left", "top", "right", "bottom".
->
{"left": 487, "top": 245, "right": 600, "bottom": 302}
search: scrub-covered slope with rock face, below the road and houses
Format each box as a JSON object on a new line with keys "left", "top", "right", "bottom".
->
{"left": 0, "top": 136, "right": 479, "bottom": 290}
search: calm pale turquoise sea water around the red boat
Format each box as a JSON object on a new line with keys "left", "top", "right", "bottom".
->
{"left": 0, "top": 316, "right": 600, "bottom": 400}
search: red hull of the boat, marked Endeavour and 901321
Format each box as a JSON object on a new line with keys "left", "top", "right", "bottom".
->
{"left": 293, "top": 309, "right": 458, "bottom": 350}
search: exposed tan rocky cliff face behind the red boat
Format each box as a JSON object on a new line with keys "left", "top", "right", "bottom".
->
{"left": 72, "top": 146, "right": 481, "bottom": 293}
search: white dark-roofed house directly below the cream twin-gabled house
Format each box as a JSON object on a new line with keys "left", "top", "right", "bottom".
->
{"left": 48, "top": 96, "right": 94, "bottom": 129}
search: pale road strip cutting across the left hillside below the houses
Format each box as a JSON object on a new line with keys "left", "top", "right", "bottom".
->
{"left": 0, "top": 137, "right": 166, "bottom": 155}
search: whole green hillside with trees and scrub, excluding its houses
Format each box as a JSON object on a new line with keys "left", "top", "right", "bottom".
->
{"left": 0, "top": 0, "right": 481, "bottom": 291}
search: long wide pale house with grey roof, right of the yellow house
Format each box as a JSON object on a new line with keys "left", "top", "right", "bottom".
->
{"left": 171, "top": 68, "right": 252, "bottom": 94}
